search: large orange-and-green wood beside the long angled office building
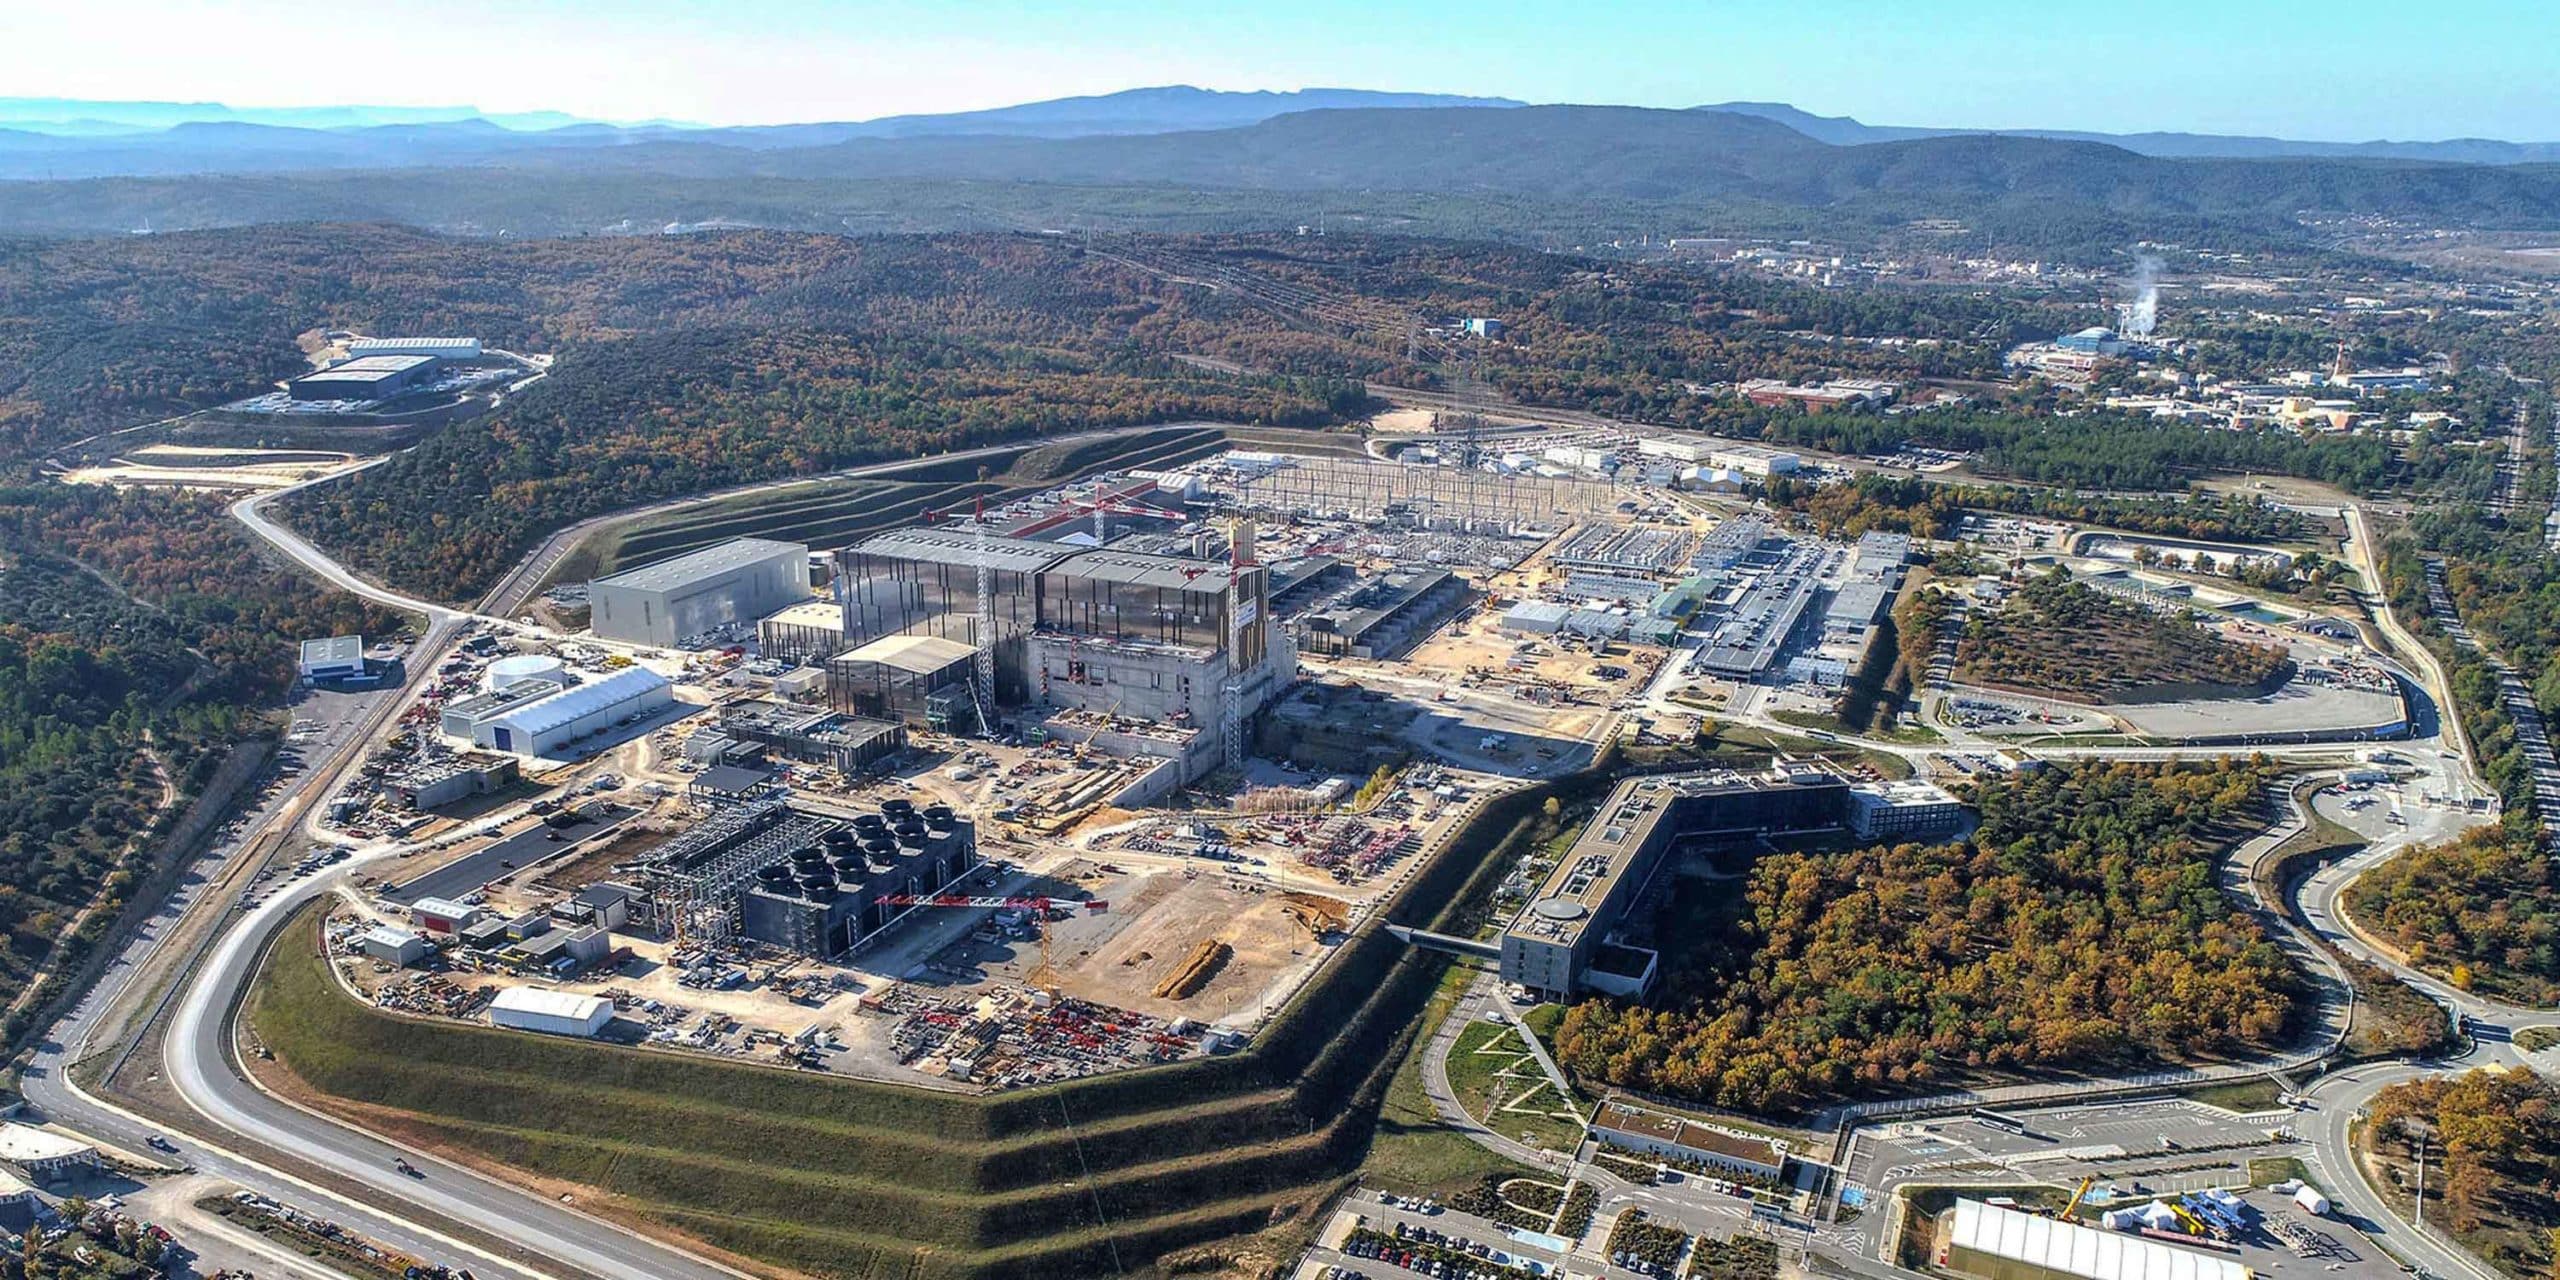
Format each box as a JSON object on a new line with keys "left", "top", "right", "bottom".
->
{"left": 1556, "top": 760, "right": 2301, "bottom": 1111}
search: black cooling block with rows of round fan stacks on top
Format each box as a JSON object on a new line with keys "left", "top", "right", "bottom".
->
{"left": 640, "top": 796, "right": 978, "bottom": 957}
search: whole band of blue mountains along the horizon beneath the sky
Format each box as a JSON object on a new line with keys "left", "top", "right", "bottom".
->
{"left": 0, "top": 87, "right": 2560, "bottom": 256}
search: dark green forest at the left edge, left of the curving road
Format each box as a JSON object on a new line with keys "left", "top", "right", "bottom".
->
{"left": 0, "top": 484, "right": 402, "bottom": 1044}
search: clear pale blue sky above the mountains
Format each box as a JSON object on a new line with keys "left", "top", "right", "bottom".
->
{"left": 15, "top": 0, "right": 2560, "bottom": 141}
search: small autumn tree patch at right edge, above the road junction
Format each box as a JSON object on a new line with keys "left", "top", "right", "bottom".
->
{"left": 2348, "top": 827, "right": 2560, "bottom": 1006}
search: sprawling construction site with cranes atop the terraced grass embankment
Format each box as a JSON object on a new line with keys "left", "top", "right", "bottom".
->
{"left": 309, "top": 432, "right": 1914, "bottom": 1088}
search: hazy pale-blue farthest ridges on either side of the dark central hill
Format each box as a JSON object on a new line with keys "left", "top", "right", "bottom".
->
{"left": 0, "top": 84, "right": 2560, "bottom": 179}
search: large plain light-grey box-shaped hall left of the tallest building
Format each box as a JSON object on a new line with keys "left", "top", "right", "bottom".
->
{"left": 586, "top": 538, "right": 809, "bottom": 648}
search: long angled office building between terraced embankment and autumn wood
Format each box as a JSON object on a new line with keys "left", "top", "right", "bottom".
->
{"left": 1500, "top": 763, "right": 1964, "bottom": 998}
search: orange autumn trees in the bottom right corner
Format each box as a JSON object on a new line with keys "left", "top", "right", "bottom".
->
{"left": 2365, "top": 1070, "right": 2560, "bottom": 1280}
